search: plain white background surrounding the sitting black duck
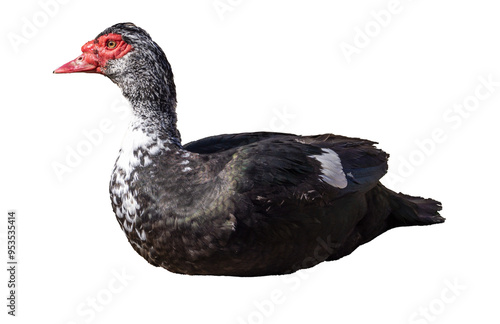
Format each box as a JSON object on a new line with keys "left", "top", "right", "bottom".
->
{"left": 0, "top": 0, "right": 500, "bottom": 324}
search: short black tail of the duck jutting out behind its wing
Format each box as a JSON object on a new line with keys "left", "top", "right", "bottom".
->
{"left": 387, "top": 189, "right": 445, "bottom": 227}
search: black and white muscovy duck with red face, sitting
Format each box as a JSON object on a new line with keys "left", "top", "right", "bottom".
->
{"left": 54, "top": 23, "right": 444, "bottom": 276}
